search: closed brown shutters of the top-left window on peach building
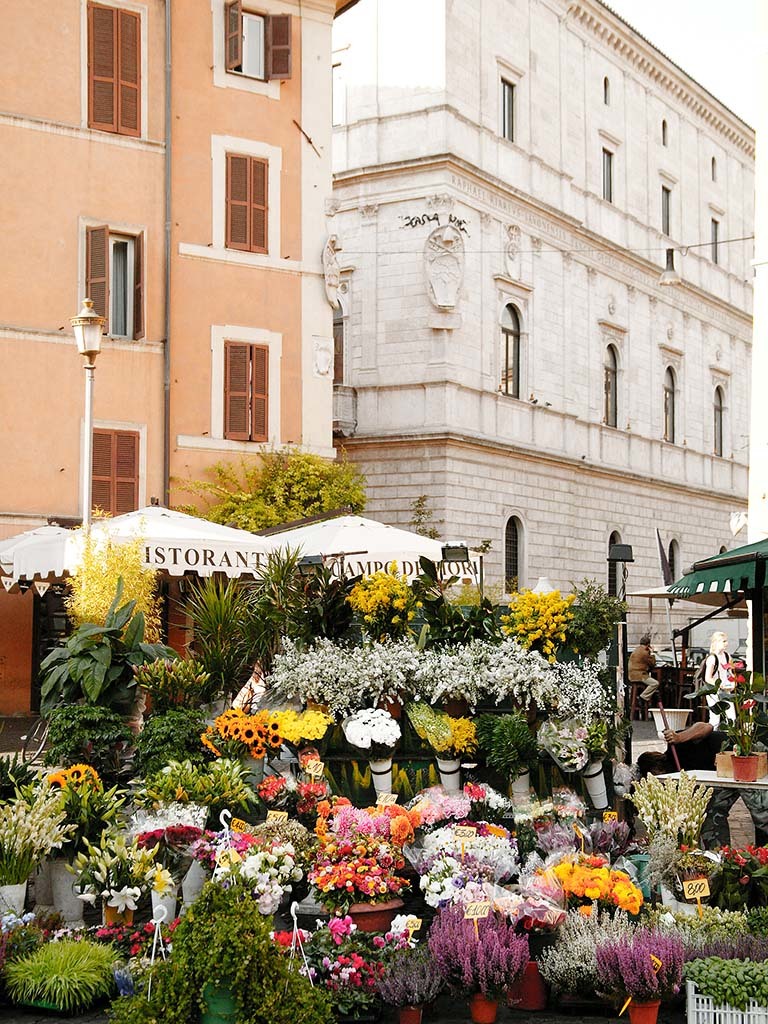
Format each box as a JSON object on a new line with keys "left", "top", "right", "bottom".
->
{"left": 88, "top": 3, "right": 141, "bottom": 136}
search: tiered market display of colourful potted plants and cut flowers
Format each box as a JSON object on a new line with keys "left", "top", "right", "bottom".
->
{"left": 0, "top": 556, "right": 768, "bottom": 1024}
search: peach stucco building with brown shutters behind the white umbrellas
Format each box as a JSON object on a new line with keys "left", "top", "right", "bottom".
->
{"left": 0, "top": 0, "right": 349, "bottom": 714}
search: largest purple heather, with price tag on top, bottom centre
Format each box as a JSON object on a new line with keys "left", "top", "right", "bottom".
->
{"left": 429, "top": 906, "right": 529, "bottom": 999}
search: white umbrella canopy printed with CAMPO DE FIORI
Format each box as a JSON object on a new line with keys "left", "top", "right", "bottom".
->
{"left": 269, "top": 515, "right": 477, "bottom": 579}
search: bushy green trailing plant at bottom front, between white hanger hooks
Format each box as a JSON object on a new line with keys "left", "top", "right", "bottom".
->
{"left": 114, "top": 883, "right": 332, "bottom": 1024}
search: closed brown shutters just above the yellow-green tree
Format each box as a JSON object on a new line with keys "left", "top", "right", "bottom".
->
{"left": 224, "top": 341, "right": 269, "bottom": 441}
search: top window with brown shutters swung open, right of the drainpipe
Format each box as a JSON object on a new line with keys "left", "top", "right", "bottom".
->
{"left": 224, "top": 0, "right": 292, "bottom": 82}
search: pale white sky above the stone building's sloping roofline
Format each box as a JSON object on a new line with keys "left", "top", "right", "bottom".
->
{"left": 604, "top": 0, "right": 757, "bottom": 126}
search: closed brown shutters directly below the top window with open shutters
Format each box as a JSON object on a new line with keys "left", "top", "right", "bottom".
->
{"left": 225, "top": 153, "right": 269, "bottom": 253}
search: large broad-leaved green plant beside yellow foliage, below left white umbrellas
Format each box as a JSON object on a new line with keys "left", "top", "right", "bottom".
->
{"left": 40, "top": 578, "right": 177, "bottom": 714}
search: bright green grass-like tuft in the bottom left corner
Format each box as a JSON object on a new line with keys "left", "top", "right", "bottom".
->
{"left": 4, "top": 939, "right": 116, "bottom": 1014}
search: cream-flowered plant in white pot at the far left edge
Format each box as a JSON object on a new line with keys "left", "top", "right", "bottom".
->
{"left": 0, "top": 786, "right": 68, "bottom": 915}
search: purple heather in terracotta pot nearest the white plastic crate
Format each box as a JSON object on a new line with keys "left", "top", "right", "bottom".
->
{"left": 597, "top": 928, "right": 685, "bottom": 1002}
